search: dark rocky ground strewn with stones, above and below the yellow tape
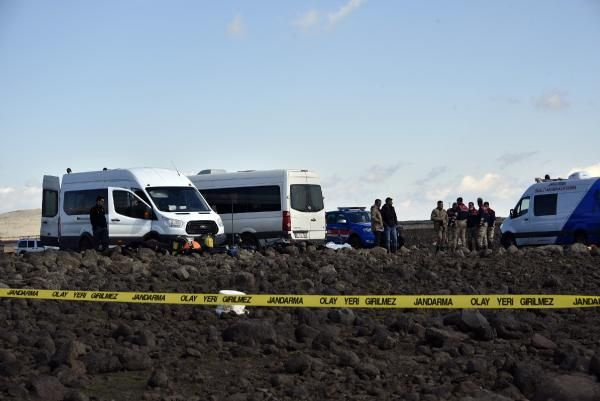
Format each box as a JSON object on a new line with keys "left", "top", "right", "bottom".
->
{"left": 0, "top": 235, "right": 600, "bottom": 401}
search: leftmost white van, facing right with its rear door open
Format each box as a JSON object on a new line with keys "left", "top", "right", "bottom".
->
{"left": 40, "top": 168, "right": 225, "bottom": 250}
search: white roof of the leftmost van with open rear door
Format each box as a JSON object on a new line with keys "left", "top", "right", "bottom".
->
{"left": 62, "top": 167, "right": 191, "bottom": 187}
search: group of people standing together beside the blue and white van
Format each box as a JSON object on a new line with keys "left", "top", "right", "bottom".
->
{"left": 431, "top": 197, "right": 496, "bottom": 251}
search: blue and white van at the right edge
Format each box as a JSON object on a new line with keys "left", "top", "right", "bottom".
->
{"left": 500, "top": 173, "right": 600, "bottom": 246}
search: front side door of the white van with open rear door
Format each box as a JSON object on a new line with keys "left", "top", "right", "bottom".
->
{"left": 107, "top": 188, "right": 152, "bottom": 245}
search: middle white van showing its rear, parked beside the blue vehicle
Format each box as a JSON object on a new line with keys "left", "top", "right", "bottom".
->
{"left": 189, "top": 170, "right": 326, "bottom": 247}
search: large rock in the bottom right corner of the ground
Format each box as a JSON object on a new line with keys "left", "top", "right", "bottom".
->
{"left": 533, "top": 375, "right": 600, "bottom": 401}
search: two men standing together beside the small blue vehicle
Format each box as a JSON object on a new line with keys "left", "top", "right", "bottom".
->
{"left": 371, "top": 197, "right": 402, "bottom": 253}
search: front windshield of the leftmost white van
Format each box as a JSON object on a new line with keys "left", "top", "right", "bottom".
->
{"left": 146, "top": 187, "right": 210, "bottom": 212}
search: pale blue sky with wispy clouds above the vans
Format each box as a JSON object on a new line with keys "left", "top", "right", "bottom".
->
{"left": 0, "top": 0, "right": 600, "bottom": 220}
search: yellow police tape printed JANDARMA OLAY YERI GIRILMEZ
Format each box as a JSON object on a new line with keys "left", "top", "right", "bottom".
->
{"left": 0, "top": 288, "right": 600, "bottom": 309}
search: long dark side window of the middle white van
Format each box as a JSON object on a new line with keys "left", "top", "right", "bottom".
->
{"left": 200, "top": 185, "right": 281, "bottom": 214}
